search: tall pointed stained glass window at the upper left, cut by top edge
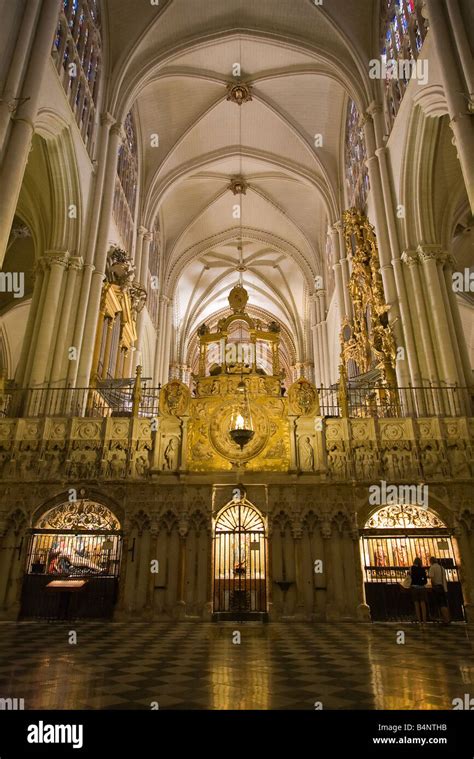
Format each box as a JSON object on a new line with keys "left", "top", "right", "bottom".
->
{"left": 52, "top": 0, "right": 102, "bottom": 155}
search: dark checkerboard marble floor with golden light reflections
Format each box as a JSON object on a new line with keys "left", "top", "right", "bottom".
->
{"left": 0, "top": 622, "right": 474, "bottom": 709}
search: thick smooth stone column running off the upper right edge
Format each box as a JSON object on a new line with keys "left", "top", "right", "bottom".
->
{"left": 425, "top": 0, "right": 474, "bottom": 213}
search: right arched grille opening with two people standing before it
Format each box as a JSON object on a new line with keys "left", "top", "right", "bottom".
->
{"left": 361, "top": 504, "right": 464, "bottom": 622}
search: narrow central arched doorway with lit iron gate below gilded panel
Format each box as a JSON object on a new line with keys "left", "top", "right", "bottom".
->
{"left": 213, "top": 499, "right": 267, "bottom": 620}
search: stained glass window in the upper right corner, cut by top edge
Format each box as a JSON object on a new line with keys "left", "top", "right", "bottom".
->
{"left": 380, "top": 0, "right": 427, "bottom": 131}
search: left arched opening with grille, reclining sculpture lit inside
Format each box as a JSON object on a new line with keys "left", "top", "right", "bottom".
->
{"left": 20, "top": 499, "right": 122, "bottom": 619}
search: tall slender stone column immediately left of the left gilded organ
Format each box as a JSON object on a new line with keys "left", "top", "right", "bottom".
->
{"left": 78, "top": 123, "right": 122, "bottom": 387}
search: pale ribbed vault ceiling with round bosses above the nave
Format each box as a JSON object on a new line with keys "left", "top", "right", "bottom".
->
{"left": 103, "top": 0, "right": 378, "bottom": 368}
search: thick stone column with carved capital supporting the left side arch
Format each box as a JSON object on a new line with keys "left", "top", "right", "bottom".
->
{"left": 30, "top": 252, "right": 68, "bottom": 386}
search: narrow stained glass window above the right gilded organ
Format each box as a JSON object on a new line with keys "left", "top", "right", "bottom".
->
{"left": 345, "top": 100, "right": 369, "bottom": 211}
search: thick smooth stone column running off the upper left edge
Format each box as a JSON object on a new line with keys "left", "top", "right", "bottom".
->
{"left": 0, "top": 0, "right": 59, "bottom": 266}
